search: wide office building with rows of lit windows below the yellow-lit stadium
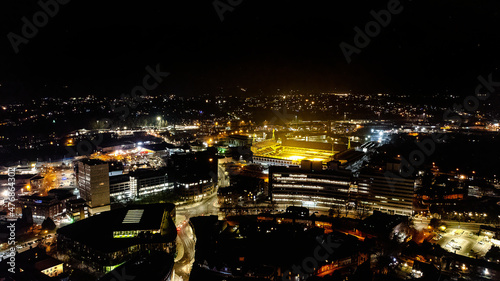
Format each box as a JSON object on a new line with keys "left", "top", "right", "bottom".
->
{"left": 269, "top": 161, "right": 416, "bottom": 216}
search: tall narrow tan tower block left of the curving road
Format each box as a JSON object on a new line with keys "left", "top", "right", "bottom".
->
{"left": 77, "top": 159, "right": 110, "bottom": 213}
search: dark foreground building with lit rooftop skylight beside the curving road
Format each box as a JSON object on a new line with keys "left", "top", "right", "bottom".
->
{"left": 57, "top": 203, "right": 177, "bottom": 272}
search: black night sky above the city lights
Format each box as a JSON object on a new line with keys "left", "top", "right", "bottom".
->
{"left": 0, "top": 0, "right": 500, "bottom": 102}
